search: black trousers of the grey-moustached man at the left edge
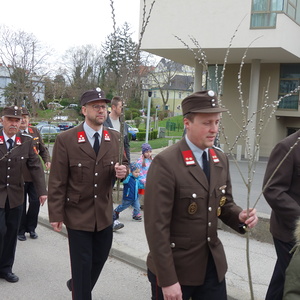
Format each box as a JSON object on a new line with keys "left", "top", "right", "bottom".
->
{"left": 0, "top": 198, "right": 22, "bottom": 273}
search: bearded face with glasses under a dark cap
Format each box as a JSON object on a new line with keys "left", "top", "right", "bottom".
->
{"left": 82, "top": 100, "right": 107, "bottom": 129}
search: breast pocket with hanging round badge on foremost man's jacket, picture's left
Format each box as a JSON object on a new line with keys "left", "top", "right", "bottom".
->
{"left": 179, "top": 186, "right": 207, "bottom": 219}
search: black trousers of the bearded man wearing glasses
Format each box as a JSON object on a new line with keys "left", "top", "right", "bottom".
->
{"left": 67, "top": 226, "right": 112, "bottom": 300}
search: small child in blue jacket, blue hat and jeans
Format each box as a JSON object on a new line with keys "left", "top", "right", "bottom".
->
{"left": 114, "top": 163, "right": 144, "bottom": 221}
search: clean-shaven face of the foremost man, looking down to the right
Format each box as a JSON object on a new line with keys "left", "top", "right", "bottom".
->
{"left": 184, "top": 113, "right": 221, "bottom": 150}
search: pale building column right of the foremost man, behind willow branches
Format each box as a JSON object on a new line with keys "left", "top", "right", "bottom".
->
{"left": 245, "top": 59, "right": 260, "bottom": 159}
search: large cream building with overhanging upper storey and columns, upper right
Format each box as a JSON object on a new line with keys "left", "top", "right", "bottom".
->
{"left": 140, "top": 0, "right": 300, "bottom": 157}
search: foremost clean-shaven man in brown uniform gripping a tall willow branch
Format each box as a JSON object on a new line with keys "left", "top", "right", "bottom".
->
{"left": 144, "top": 91, "right": 257, "bottom": 300}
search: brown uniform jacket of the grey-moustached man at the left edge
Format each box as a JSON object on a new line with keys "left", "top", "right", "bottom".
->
{"left": 0, "top": 130, "right": 47, "bottom": 208}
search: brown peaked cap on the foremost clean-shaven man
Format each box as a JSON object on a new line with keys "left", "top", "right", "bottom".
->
{"left": 181, "top": 90, "right": 228, "bottom": 115}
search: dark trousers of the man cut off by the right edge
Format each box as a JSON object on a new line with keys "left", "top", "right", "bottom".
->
{"left": 266, "top": 237, "right": 295, "bottom": 300}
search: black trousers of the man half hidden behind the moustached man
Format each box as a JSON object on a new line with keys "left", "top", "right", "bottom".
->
{"left": 19, "top": 182, "right": 40, "bottom": 234}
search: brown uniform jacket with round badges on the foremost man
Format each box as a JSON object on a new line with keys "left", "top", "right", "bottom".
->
{"left": 144, "top": 139, "right": 242, "bottom": 287}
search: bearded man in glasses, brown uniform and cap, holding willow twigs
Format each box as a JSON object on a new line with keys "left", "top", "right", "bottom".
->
{"left": 48, "top": 89, "right": 128, "bottom": 300}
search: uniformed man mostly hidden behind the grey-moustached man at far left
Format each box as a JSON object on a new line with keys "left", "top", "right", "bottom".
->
{"left": 18, "top": 107, "right": 51, "bottom": 241}
